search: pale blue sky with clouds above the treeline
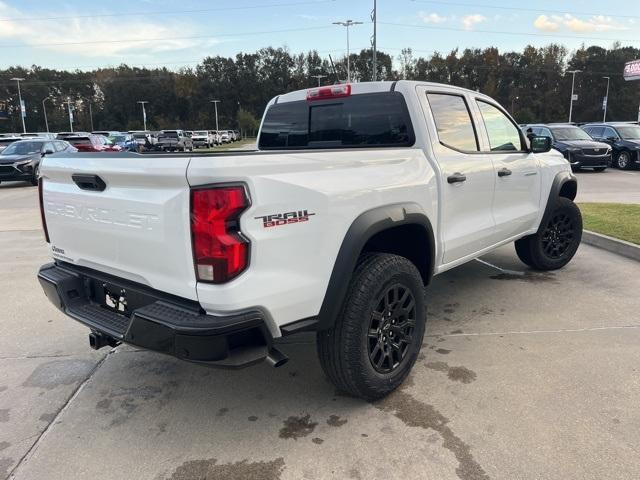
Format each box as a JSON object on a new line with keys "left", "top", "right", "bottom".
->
{"left": 0, "top": 0, "right": 640, "bottom": 70}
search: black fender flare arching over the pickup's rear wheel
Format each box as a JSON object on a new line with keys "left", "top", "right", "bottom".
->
{"left": 316, "top": 203, "right": 435, "bottom": 330}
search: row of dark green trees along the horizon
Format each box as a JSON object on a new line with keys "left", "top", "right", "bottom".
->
{"left": 0, "top": 44, "right": 640, "bottom": 132}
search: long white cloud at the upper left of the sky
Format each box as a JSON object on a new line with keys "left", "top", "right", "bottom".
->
{"left": 0, "top": 0, "right": 219, "bottom": 58}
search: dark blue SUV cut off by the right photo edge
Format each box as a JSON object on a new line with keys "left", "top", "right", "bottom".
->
{"left": 582, "top": 122, "right": 640, "bottom": 170}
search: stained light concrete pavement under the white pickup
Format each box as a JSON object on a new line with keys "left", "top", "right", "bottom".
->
{"left": 0, "top": 177, "right": 640, "bottom": 480}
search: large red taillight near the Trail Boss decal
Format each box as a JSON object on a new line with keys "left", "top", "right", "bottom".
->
{"left": 191, "top": 185, "right": 249, "bottom": 283}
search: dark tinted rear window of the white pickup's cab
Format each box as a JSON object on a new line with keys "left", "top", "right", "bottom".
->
{"left": 259, "top": 92, "right": 415, "bottom": 150}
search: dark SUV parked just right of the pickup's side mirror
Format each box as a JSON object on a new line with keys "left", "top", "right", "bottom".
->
{"left": 524, "top": 124, "right": 611, "bottom": 172}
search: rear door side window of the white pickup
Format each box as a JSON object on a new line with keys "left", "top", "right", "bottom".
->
{"left": 427, "top": 93, "right": 478, "bottom": 152}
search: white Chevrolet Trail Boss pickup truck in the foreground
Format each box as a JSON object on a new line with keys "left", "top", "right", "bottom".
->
{"left": 39, "top": 81, "right": 582, "bottom": 399}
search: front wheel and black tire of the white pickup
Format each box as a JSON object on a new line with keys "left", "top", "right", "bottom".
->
{"left": 515, "top": 197, "right": 582, "bottom": 271}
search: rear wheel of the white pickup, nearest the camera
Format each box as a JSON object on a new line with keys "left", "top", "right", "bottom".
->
{"left": 316, "top": 253, "right": 426, "bottom": 400}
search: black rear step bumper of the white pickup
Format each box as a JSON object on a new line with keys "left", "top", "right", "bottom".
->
{"left": 38, "top": 263, "right": 273, "bottom": 368}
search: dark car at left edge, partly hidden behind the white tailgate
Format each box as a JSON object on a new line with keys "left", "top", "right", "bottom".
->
{"left": 0, "top": 138, "right": 78, "bottom": 185}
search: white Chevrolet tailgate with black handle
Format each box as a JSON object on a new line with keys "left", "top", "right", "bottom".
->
{"left": 41, "top": 153, "right": 197, "bottom": 300}
